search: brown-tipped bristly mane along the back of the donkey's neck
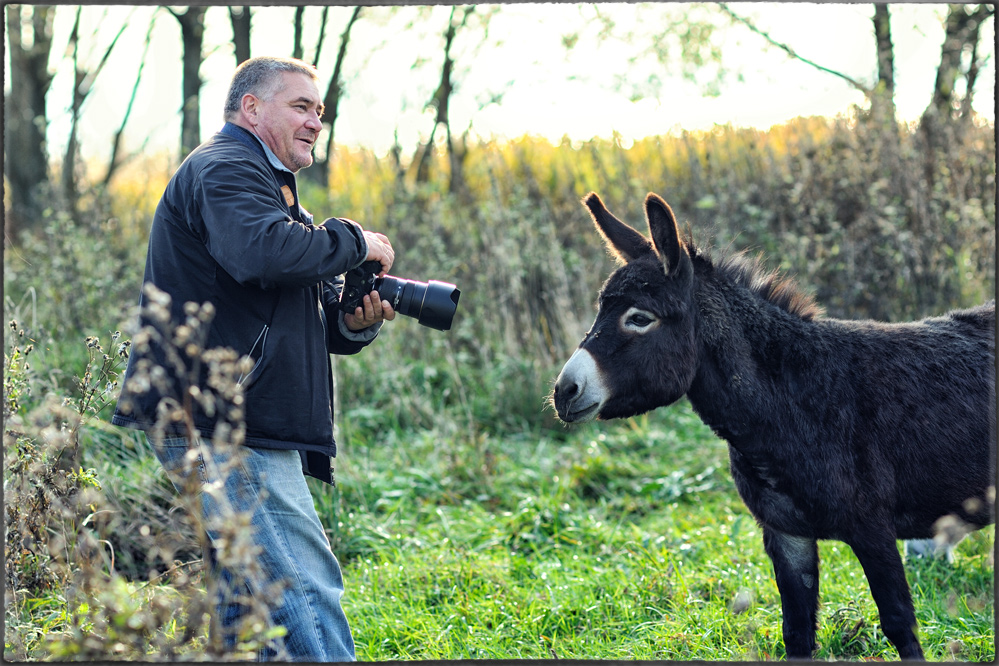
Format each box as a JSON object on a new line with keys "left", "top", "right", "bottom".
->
{"left": 686, "top": 237, "right": 824, "bottom": 321}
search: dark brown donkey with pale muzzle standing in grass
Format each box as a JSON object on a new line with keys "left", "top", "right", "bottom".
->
{"left": 551, "top": 193, "right": 996, "bottom": 659}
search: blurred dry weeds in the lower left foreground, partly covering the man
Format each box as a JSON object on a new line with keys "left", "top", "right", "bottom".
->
{"left": 4, "top": 302, "right": 283, "bottom": 661}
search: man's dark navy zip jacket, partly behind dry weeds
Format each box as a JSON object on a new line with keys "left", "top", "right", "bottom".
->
{"left": 112, "top": 124, "right": 379, "bottom": 483}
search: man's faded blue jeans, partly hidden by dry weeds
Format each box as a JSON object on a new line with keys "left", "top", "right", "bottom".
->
{"left": 150, "top": 438, "right": 355, "bottom": 662}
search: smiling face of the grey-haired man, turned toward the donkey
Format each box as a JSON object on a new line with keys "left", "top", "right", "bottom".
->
{"left": 251, "top": 72, "right": 323, "bottom": 173}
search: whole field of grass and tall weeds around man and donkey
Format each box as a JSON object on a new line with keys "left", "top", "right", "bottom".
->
{"left": 3, "top": 114, "right": 996, "bottom": 661}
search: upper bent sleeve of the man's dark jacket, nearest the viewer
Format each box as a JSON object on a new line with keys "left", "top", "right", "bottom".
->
{"left": 188, "top": 158, "right": 367, "bottom": 289}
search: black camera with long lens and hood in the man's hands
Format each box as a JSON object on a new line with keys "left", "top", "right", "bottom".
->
{"left": 340, "top": 261, "right": 461, "bottom": 331}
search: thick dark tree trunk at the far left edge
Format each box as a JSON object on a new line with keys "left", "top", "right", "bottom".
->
{"left": 4, "top": 5, "right": 55, "bottom": 241}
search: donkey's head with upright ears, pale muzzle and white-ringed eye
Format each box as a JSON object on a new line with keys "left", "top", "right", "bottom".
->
{"left": 552, "top": 193, "right": 697, "bottom": 423}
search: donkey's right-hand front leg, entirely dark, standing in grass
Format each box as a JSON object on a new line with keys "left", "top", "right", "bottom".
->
{"left": 849, "top": 530, "right": 923, "bottom": 659}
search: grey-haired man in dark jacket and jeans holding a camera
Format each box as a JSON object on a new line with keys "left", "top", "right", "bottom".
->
{"left": 112, "top": 58, "right": 395, "bottom": 661}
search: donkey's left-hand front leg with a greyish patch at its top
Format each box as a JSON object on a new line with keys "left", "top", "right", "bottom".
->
{"left": 763, "top": 527, "right": 819, "bottom": 659}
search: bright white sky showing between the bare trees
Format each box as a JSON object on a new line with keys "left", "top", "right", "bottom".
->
{"left": 15, "top": 3, "right": 995, "bottom": 161}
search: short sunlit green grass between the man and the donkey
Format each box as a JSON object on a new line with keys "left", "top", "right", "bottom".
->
{"left": 304, "top": 403, "right": 995, "bottom": 661}
